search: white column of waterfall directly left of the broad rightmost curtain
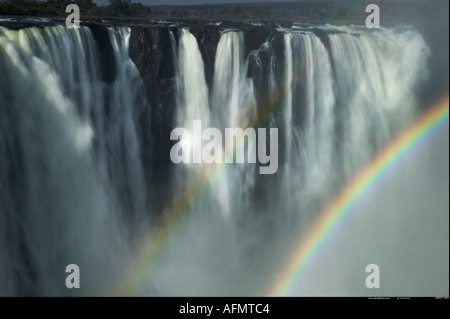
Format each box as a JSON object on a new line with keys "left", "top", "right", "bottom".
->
{"left": 290, "top": 33, "right": 335, "bottom": 216}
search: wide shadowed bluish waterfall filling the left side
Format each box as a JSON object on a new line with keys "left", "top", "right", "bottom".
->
{"left": 0, "top": 27, "right": 146, "bottom": 295}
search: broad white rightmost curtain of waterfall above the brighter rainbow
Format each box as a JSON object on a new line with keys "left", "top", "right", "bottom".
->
{"left": 329, "top": 28, "right": 428, "bottom": 181}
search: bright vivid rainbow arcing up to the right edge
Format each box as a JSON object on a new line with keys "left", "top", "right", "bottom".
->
{"left": 267, "top": 95, "right": 449, "bottom": 296}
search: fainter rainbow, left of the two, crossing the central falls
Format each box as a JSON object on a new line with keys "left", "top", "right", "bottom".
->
{"left": 111, "top": 47, "right": 294, "bottom": 296}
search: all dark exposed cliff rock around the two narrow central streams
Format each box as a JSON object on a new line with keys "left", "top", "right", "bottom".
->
{"left": 125, "top": 21, "right": 284, "bottom": 202}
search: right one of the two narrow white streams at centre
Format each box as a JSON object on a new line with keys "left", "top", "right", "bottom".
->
{"left": 211, "top": 31, "right": 256, "bottom": 220}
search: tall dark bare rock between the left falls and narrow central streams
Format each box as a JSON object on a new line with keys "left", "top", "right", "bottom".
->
{"left": 129, "top": 27, "right": 175, "bottom": 200}
